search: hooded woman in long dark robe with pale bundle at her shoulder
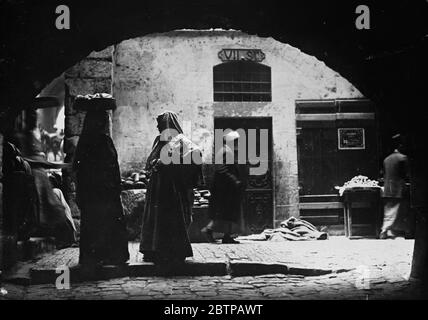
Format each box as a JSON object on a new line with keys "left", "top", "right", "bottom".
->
{"left": 140, "top": 111, "right": 201, "bottom": 264}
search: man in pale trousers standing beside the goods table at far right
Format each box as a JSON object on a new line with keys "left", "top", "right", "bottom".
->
{"left": 379, "top": 134, "right": 409, "bottom": 239}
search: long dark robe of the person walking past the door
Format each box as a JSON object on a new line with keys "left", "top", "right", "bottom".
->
{"left": 209, "top": 148, "right": 242, "bottom": 226}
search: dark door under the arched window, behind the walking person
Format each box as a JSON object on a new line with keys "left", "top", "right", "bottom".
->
{"left": 214, "top": 117, "right": 273, "bottom": 234}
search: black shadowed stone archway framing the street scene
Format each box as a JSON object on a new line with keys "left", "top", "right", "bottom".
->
{"left": 0, "top": 0, "right": 427, "bottom": 282}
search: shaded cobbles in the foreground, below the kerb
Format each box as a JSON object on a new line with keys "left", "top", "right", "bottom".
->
{"left": 0, "top": 271, "right": 420, "bottom": 300}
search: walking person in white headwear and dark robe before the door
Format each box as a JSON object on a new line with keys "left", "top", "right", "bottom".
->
{"left": 201, "top": 131, "right": 242, "bottom": 243}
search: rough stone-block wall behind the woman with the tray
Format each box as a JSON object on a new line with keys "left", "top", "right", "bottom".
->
{"left": 63, "top": 47, "right": 113, "bottom": 217}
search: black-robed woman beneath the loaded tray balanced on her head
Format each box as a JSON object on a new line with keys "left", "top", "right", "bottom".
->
{"left": 74, "top": 111, "right": 129, "bottom": 265}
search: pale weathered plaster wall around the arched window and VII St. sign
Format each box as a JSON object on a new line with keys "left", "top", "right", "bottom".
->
{"left": 113, "top": 31, "right": 362, "bottom": 221}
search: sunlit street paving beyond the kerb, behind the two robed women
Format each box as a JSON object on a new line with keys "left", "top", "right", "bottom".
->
{"left": 22, "top": 237, "right": 414, "bottom": 270}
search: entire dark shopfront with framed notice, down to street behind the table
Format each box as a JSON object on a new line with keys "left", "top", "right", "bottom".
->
{"left": 296, "top": 99, "right": 380, "bottom": 235}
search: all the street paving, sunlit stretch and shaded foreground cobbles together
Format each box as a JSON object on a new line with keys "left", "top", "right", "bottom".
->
{"left": 3, "top": 237, "right": 421, "bottom": 299}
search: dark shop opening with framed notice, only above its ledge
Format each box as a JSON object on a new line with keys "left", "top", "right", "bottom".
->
{"left": 296, "top": 99, "right": 380, "bottom": 196}
